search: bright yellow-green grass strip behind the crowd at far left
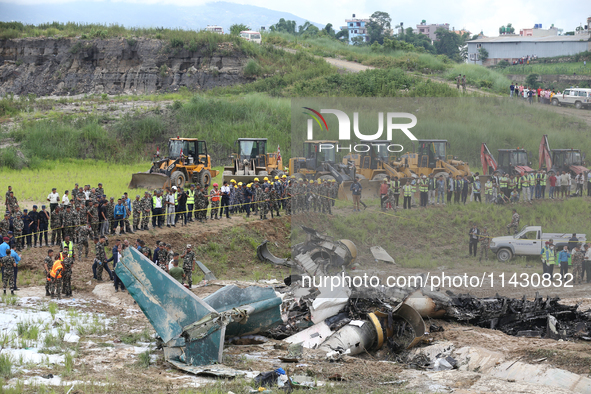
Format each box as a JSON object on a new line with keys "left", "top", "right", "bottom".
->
{"left": 0, "top": 159, "right": 222, "bottom": 205}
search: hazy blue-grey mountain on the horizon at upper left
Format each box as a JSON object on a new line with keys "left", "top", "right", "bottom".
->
{"left": 0, "top": 1, "right": 324, "bottom": 31}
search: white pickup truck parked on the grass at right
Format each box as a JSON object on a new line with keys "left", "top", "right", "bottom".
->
{"left": 490, "top": 226, "right": 587, "bottom": 262}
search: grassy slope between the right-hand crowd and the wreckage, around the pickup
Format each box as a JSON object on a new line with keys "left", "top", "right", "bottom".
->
{"left": 292, "top": 198, "right": 591, "bottom": 269}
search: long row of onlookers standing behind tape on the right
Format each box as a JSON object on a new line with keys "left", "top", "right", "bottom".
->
{"left": 370, "top": 170, "right": 591, "bottom": 210}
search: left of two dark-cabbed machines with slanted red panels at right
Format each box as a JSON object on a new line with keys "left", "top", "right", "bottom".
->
{"left": 480, "top": 142, "right": 533, "bottom": 176}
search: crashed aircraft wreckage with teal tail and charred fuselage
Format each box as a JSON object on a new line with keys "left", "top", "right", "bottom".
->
{"left": 115, "top": 228, "right": 591, "bottom": 376}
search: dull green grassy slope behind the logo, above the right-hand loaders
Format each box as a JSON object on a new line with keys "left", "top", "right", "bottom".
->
{"left": 292, "top": 97, "right": 591, "bottom": 168}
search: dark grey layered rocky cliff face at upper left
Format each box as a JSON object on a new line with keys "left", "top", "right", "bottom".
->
{"left": 0, "top": 38, "right": 247, "bottom": 96}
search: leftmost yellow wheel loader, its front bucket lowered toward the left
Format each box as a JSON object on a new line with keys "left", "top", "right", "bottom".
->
{"left": 129, "top": 137, "right": 218, "bottom": 189}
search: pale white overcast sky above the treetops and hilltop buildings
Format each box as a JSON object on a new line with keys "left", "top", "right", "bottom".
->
{"left": 3, "top": 0, "right": 591, "bottom": 36}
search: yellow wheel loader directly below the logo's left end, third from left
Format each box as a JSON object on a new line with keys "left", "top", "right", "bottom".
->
{"left": 289, "top": 140, "right": 355, "bottom": 183}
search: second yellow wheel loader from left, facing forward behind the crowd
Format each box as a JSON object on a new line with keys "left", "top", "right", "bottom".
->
{"left": 222, "top": 138, "right": 284, "bottom": 183}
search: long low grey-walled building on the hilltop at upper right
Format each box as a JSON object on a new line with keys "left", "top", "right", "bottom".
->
{"left": 467, "top": 33, "right": 591, "bottom": 66}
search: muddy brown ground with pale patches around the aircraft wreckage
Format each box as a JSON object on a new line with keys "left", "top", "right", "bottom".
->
{"left": 0, "top": 212, "right": 591, "bottom": 394}
